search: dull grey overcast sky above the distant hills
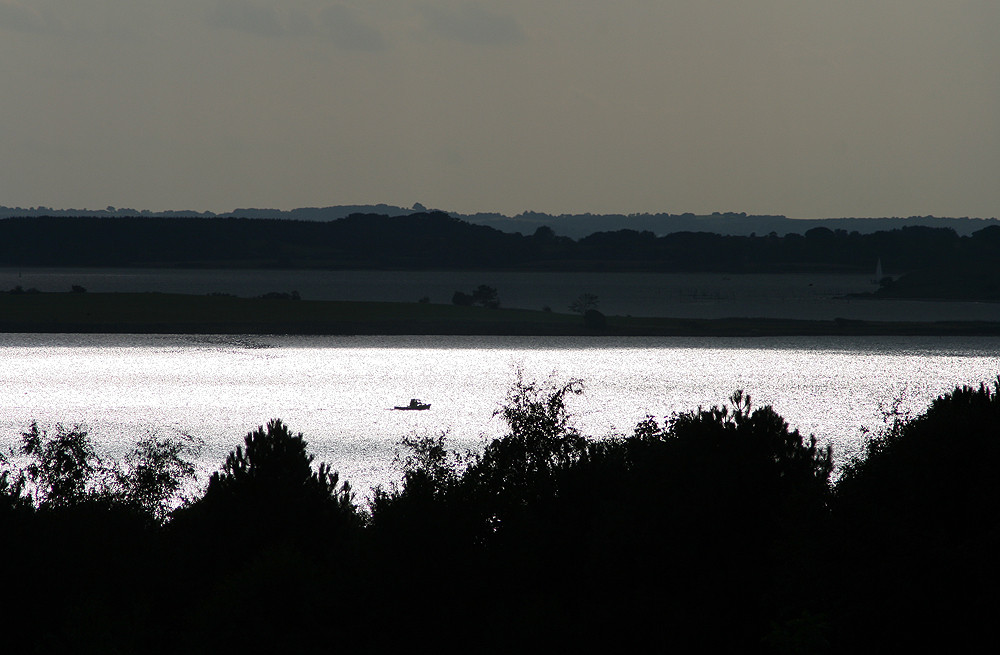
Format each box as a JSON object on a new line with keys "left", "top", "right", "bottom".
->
{"left": 0, "top": 0, "right": 1000, "bottom": 218}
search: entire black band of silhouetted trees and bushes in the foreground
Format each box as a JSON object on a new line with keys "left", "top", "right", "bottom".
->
{"left": 0, "top": 380, "right": 1000, "bottom": 653}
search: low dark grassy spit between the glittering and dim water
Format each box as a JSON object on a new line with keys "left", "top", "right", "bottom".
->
{"left": 0, "top": 293, "right": 1000, "bottom": 337}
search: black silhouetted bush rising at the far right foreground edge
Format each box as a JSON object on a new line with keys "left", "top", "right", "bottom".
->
{"left": 834, "top": 380, "right": 1000, "bottom": 650}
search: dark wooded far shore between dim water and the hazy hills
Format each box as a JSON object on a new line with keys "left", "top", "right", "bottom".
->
{"left": 0, "top": 212, "right": 1000, "bottom": 300}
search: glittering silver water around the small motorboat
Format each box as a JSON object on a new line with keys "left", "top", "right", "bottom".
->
{"left": 0, "top": 334, "right": 1000, "bottom": 493}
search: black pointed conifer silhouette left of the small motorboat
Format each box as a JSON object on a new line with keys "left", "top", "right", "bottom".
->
{"left": 169, "top": 419, "right": 364, "bottom": 652}
